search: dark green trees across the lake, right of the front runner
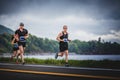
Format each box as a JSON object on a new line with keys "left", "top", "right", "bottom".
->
{"left": 69, "top": 40, "right": 120, "bottom": 54}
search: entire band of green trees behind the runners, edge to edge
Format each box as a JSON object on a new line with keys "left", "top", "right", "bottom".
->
{"left": 0, "top": 33, "right": 120, "bottom": 54}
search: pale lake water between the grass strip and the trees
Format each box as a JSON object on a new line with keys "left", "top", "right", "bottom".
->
{"left": 25, "top": 54, "right": 120, "bottom": 60}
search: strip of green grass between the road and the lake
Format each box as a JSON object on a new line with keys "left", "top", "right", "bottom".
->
{"left": 0, "top": 57, "right": 120, "bottom": 69}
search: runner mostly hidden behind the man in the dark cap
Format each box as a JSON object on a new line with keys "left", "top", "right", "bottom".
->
{"left": 11, "top": 35, "right": 20, "bottom": 64}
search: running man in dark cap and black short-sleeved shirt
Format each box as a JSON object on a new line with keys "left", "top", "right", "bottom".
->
{"left": 15, "top": 23, "right": 29, "bottom": 65}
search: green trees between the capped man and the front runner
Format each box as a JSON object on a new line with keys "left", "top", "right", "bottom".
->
{"left": 26, "top": 35, "right": 58, "bottom": 53}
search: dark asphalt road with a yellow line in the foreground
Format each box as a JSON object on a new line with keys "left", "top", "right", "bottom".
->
{"left": 0, "top": 63, "right": 120, "bottom": 80}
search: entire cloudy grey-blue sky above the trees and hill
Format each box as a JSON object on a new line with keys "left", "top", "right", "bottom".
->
{"left": 0, "top": 0, "right": 120, "bottom": 43}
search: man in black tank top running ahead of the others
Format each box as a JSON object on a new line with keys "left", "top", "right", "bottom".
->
{"left": 55, "top": 25, "right": 71, "bottom": 67}
